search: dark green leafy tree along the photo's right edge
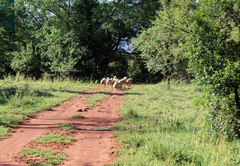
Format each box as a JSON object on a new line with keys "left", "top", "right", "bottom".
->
{"left": 178, "top": 0, "right": 240, "bottom": 137}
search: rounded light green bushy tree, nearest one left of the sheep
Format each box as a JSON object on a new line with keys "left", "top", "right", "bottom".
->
{"left": 39, "top": 27, "right": 81, "bottom": 77}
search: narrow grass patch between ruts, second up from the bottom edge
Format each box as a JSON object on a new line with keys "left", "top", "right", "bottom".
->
{"left": 31, "top": 133, "right": 76, "bottom": 145}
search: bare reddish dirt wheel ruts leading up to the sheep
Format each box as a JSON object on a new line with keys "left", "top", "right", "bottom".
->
{"left": 0, "top": 87, "right": 126, "bottom": 166}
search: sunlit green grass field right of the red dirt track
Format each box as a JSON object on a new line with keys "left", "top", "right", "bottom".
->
{"left": 113, "top": 82, "right": 240, "bottom": 166}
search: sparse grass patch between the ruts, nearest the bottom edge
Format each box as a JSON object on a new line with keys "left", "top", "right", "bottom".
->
{"left": 19, "top": 148, "right": 66, "bottom": 165}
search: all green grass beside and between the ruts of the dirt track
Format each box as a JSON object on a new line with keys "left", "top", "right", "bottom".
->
{"left": 0, "top": 76, "right": 240, "bottom": 166}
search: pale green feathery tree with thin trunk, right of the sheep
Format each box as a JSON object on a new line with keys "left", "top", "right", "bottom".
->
{"left": 132, "top": 1, "right": 186, "bottom": 87}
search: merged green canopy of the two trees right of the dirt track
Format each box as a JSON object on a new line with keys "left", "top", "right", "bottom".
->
{"left": 133, "top": 0, "right": 240, "bottom": 137}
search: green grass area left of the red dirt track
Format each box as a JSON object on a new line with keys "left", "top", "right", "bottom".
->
{"left": 0, "top": 75, "right": 99, "bottom": 139}
